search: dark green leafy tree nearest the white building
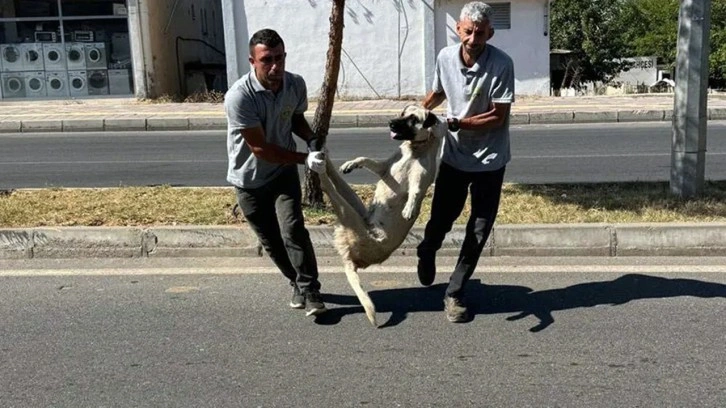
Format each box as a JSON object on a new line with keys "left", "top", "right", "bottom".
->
{"left": 550, "top": 0, "right": 626, "bottom": 87}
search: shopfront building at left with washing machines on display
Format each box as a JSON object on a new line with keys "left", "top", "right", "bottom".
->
{"left": 0, "top": 0, "right": 226, "bottom": 100}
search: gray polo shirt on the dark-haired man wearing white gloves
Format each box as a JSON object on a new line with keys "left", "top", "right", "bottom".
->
{"left": 224, "top": 70, "right": 308, "bottom": 188}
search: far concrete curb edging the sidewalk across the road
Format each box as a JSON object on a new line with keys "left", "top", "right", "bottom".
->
{"left": 0, "top": 108, "right": 726, "bottom": 133}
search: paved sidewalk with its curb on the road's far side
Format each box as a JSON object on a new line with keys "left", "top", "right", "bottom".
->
{"left": 0, "top": 94, "right": 726, "bottom": 132}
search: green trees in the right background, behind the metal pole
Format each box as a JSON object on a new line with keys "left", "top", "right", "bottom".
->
{"left": 550, "top": 0, "right": 726, "bottom": 89}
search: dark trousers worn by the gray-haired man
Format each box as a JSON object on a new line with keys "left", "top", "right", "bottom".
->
{"left": 418, "top": 163, "right": 504, "bottom": 297}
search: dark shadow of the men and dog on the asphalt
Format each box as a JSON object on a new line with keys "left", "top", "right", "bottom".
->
{"left": 316, "top": 274, "right": 726, "bottom": 332}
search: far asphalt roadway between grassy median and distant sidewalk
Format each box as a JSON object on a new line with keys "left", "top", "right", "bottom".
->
{"left": 0, "top": 121, "right": 726, "bottom": 189}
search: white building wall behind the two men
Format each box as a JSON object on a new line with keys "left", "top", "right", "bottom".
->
{"left": 222, "top": 0, "right": 549, "bottom": 99}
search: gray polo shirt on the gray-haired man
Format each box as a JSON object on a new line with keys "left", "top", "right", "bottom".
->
{"left": 432, "top": 44, "right": 514, "bottom": 172}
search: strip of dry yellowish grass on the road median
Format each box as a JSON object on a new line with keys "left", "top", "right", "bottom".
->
{"left": 0, "top": 182, "right": 726, "bottom": 228}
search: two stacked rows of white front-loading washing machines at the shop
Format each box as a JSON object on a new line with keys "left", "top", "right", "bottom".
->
{"left": 0, "top": 38, "right": 111, "bottom": 98}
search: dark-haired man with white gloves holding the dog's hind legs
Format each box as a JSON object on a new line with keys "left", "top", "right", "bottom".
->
{"left": 224, "top": 29, "right": 326, "bottom": 316}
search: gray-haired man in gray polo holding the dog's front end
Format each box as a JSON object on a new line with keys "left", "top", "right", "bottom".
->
{"left": 417, "top": 1, "right": 514, "bottom": 322}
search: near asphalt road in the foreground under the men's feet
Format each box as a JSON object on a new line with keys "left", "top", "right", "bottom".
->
{"left": 0, "top": 258, "right": 726, "bottom": 408}
